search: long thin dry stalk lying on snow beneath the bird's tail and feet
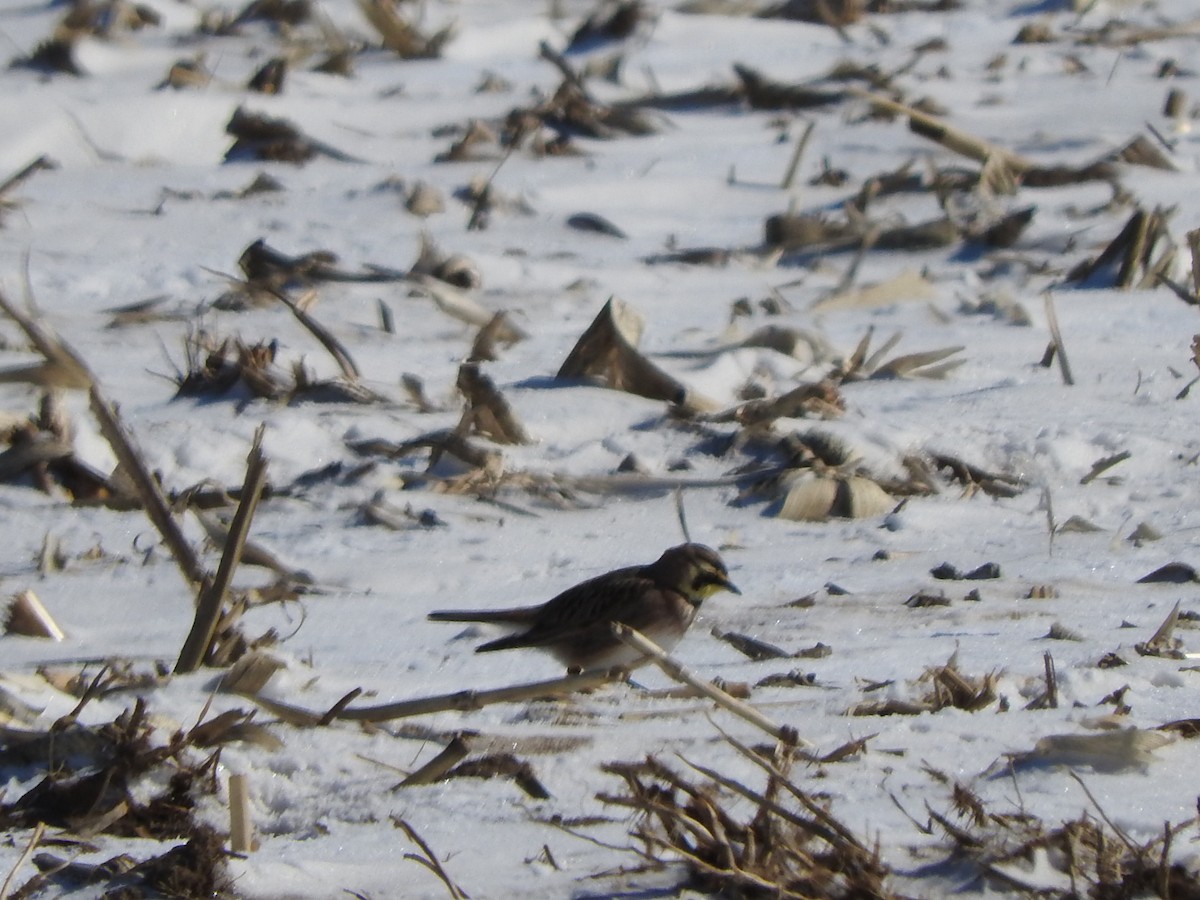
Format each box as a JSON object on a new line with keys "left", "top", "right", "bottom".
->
{"left": 244, "top": 670, "right": 625, "bottom": 725}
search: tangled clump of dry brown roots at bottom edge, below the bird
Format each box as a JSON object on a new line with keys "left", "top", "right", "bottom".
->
{"left": 600, "top": 742, "right": 898, "bottom": 900}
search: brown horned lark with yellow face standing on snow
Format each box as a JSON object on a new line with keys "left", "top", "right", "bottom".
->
{"left": 430, "top": 542, "right": 742, "bottom": 673}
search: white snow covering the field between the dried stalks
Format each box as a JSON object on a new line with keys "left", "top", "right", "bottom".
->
{"left": 0, "top": 0, "right": 1200, "bottom": 899}
